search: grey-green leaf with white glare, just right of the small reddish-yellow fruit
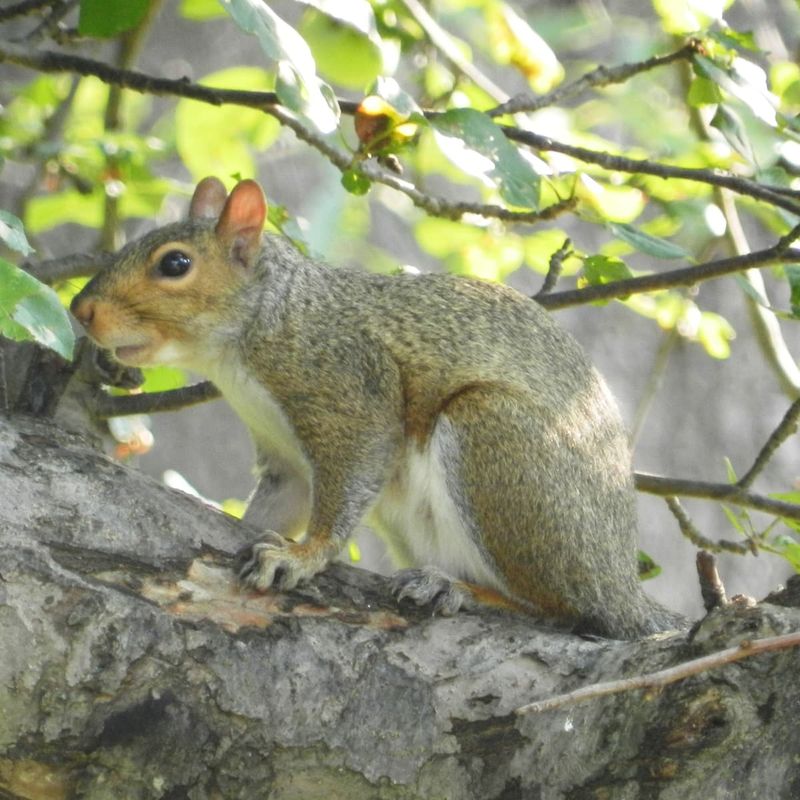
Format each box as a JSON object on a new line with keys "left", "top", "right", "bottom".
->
{"left": 431, "top": 108, "right": 541, "bottom": 209}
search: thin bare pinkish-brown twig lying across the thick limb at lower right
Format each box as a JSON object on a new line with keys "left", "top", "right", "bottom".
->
{"left": 514, "top": 633, "right": 800, "bottom": 716}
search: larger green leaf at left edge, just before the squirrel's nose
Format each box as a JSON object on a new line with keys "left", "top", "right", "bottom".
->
{"left": 0, "top": 259, "right": 75, "bottom": 359}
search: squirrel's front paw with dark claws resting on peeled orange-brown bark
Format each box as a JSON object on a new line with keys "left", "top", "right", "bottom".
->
{"left": 239, "top": 532, "right": 327, "bottom": 592}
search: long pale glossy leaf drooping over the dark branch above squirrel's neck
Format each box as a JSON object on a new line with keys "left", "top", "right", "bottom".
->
{"left": 220, "top": 0, "right": 339, "bottom": 134}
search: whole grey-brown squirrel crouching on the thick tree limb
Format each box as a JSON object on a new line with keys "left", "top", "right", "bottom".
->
{"left": 71, "top": 177, "right": 681, "bottom": 639}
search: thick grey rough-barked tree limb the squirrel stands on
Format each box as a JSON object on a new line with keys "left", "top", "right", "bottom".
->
{"left": 0, "top": 416, "right": 800, "bottom": 800}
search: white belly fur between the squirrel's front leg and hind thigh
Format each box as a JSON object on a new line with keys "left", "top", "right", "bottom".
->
{"left": 373, "top": 418, "right": 507, "bottom": 592}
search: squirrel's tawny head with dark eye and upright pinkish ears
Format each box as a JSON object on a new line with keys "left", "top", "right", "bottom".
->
{"left": 70, "top": 177, "right": 267, "bottom": 366}
